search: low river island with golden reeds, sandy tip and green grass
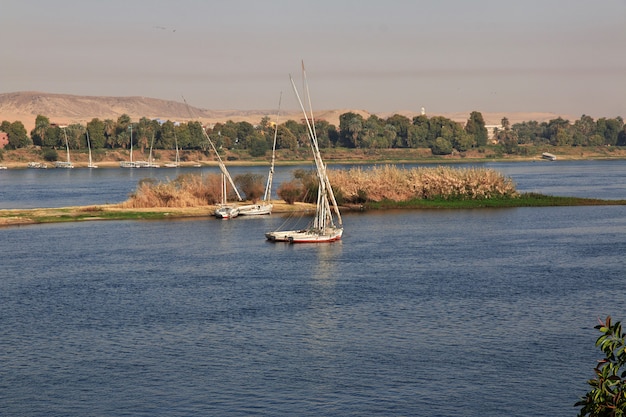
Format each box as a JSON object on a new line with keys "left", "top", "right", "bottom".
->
{"left": 0, "top": 166, "right": 626, "bottom": 226}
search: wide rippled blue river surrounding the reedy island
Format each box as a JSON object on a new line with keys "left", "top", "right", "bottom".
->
{"left": 0, "top": 161, "right": 626, "bottom": 417}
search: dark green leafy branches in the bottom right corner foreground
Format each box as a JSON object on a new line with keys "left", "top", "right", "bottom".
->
{"left": 575, "top": 316, "right": 626, "bottom": 417}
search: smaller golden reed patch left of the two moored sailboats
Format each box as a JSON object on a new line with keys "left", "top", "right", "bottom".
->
{"left": 122, "top": 174, "right": 222, "bottom": 208}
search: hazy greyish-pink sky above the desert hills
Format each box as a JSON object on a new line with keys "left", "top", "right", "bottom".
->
{"left": 0, "top": 0, "right": 626, "bottom": 117}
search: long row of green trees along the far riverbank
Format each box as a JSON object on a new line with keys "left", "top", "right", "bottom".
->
{"left": 0, "top": 111, "right": 626, "bottom": 156}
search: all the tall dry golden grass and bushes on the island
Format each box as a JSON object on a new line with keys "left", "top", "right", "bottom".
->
{"left": 122, "top": 165, "right": 518, "bottom": 208}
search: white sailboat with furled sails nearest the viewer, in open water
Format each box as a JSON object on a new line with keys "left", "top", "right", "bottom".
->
{"left": 265, "top": 63, "right": 343, "bottom": 243}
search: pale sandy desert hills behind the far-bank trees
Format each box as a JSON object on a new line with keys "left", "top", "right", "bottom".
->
{"left": 0, "top": 91, "right": 576, "bottom": 132}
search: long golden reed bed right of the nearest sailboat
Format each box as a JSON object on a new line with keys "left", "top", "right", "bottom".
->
{"left": 328, "top": 165, "right": 518, "bottom": 203}
